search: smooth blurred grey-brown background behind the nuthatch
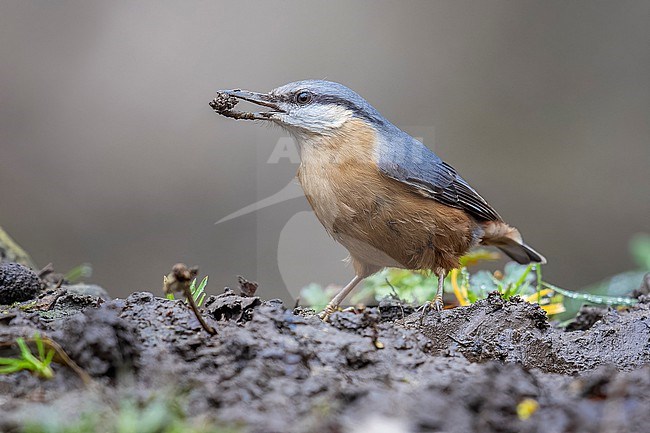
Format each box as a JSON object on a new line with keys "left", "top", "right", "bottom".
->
{"left": 0, "top": 0, "right": 650, "bottom": 300}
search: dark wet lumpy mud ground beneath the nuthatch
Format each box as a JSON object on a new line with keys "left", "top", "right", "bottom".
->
{"left": 0, "top": 276, "right": 650, "bottom": 433}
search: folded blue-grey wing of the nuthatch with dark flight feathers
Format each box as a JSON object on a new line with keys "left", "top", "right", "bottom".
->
{"left": 378, "top": 134, "right": 501, "bottom": 221}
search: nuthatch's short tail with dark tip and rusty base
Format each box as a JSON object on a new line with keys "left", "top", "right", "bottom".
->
{"left": 481, "top": 221, "right": 546, "bottom": 265}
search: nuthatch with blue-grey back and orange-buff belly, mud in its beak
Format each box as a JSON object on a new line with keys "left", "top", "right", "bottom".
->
{"left": 210, "top": 80, "right": 546, "bottom": 318}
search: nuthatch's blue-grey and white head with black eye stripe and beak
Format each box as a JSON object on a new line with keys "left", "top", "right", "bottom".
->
{"left": 215, "top": 80, "right": 385, "bottom": 137}
